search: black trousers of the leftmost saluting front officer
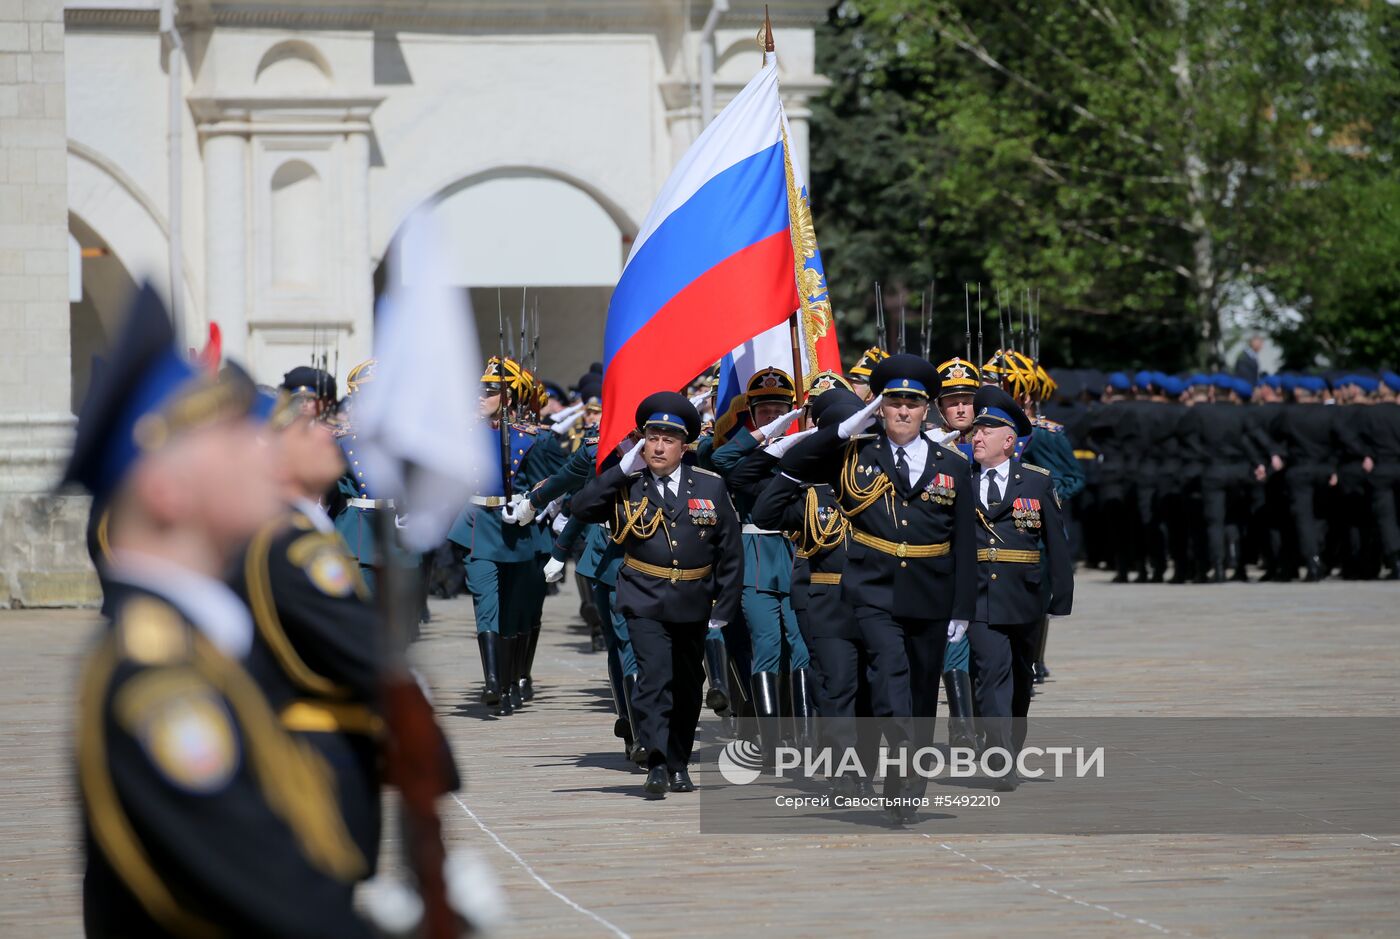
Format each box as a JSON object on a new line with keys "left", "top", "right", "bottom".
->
{"left": 627, "top": 617, "right": 707, "bottom": 772}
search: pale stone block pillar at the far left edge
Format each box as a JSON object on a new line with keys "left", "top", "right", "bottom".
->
{"left": 0, "top": 0, "right": 97, "bottom": 607}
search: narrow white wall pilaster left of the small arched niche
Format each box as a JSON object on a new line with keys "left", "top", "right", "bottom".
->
{"left": 196, "top": 134, "right": 248, "bottom": 361}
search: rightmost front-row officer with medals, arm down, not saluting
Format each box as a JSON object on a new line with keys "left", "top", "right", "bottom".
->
{"left": 967, "top": 386, "right": 1074, "bottom": 791}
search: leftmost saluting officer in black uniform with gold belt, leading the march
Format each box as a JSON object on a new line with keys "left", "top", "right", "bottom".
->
{"left": 573, "top": 392, "right": 743, "bottom": 799}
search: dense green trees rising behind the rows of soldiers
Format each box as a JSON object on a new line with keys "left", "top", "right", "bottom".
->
{"left": 812, "top": 0, "right": 1396, "bottom": 367}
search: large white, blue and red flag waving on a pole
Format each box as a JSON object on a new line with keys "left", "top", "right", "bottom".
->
{"left": 598, "top": 55, "right": 801, "bottom": 462}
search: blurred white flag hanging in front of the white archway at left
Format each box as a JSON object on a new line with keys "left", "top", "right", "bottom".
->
{"left": 354, "top": 210, "right": 500, "bottom": 551}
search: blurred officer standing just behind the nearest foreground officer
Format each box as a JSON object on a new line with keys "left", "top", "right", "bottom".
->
{"left": 234, "top": 390, "right": 384, "bottom": 875}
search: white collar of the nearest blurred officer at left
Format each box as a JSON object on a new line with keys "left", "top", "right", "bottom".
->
{"left": 111, "top": 549, "right": 253, "bottom": 659}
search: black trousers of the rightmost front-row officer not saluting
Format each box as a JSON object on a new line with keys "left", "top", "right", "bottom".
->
{"left": 967, "top": 623, "right": 1040, "bottom": 754}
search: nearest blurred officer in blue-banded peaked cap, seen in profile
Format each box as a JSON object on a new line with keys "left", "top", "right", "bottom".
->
{"left": 64, "top": 288, "right": 374, "bottom": 936}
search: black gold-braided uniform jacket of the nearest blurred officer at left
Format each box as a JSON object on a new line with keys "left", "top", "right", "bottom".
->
{"left": 78, "top": 584, "right": 375, "bottom": 938}
